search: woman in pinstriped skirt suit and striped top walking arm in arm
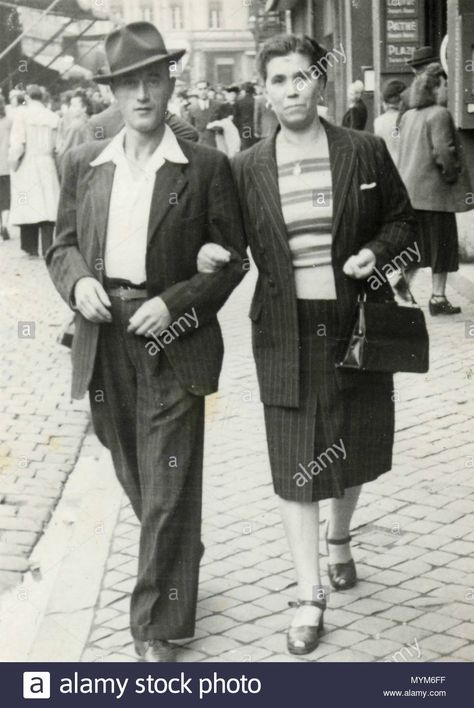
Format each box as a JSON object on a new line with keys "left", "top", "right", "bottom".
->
{"left": 198, "top": 35, "right": 414, "bottom": 654}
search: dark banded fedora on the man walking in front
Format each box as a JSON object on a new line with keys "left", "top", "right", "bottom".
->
{"left": 93, "top": 22, "right": 186, "bottom": 84}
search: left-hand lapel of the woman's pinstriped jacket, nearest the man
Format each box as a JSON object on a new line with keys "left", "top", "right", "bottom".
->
{"left": 250, "top": 135, "right": 291, "bottom": 257}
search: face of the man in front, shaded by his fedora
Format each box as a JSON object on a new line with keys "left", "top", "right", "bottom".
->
{"left": 113, "top": 63, "right": 174, "bottom": 133}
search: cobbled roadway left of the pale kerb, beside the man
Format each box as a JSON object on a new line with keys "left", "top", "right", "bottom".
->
{"left": 0, "top": 235, "right": 89, "bottom": 592}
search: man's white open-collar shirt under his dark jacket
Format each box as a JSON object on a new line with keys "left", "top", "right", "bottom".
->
{"left": 90, "top": 125, "right": 189, "bottom": 285}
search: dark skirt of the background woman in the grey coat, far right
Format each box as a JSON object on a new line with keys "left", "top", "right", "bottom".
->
{"left": 415, "top": 209, "right": 459, "bottom": 273}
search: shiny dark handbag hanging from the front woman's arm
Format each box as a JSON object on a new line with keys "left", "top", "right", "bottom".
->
{"left": 336, "top": 293, "right": 429, "bottom": 374}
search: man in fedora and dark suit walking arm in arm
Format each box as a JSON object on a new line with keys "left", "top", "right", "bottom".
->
{"left": 47, "top": 22, "right": 245, "bottom": 661}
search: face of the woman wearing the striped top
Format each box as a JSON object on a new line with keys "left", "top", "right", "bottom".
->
{"left": 265, "top": 52, "right": 321, "bottom": 131}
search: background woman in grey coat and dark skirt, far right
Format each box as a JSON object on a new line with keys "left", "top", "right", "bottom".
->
{"left": 398, "top": 63, "right": 473, "bottom": 315}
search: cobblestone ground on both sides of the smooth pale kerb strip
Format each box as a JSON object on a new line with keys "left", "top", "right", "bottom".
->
{"left": 0, "top": 234, "right": 474, "bottom": 662}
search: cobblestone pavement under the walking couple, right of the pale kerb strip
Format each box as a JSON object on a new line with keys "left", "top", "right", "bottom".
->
{"left": 78, "top": 272, "right": 474, "bottom": 662}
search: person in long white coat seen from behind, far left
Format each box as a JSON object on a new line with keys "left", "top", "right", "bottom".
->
{"left": 9, "top": 84, "right": 59, "bottom": 256}
